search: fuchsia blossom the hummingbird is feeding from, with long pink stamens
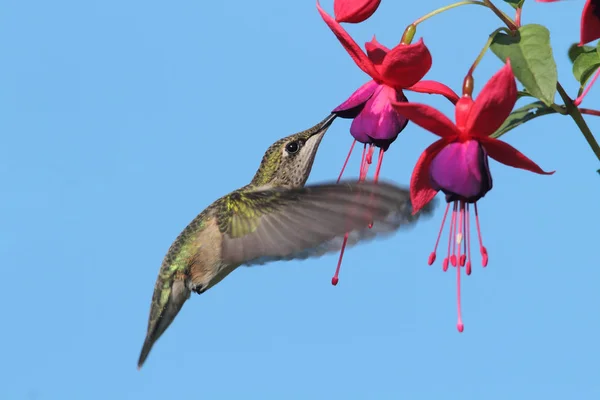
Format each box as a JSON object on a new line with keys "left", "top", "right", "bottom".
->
{"left": 317, "top": 0, "right": 458, "bottom": 285}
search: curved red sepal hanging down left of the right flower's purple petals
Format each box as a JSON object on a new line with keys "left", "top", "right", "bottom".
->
{"left": 410, "top": 139, "right": 448, "bottom": 214}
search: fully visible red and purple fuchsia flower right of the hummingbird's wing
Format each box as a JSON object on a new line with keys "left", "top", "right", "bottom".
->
{"left": 393, "top": 60, "right": 554, "bottom": 332}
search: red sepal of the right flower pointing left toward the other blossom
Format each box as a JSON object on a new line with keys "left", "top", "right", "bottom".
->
{"left": 392, "top": 103, "right": 460, "bottom": 138}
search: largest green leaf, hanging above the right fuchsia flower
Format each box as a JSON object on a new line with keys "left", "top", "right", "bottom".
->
{"left": 490, "top": 24, "right": 558, "bottom": 105}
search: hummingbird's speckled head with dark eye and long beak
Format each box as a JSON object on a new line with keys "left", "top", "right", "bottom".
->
{"left": 250, "top": 114, "right": 335, "bottom": 187}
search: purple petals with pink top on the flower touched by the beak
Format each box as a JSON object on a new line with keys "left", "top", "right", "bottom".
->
{"left": 350, "top": 85, "right": 408, "bottom": 150}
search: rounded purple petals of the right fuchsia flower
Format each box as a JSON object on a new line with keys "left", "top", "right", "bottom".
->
{"left": 429, "top": 140, "right": 492, "bottom": 203}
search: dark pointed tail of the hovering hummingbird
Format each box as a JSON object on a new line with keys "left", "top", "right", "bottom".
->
{"left": 138, "top": 280, "right": 191, "bottom": 370}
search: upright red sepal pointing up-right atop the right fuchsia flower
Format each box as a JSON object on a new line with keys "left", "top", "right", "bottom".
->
{"left": 465, "top": 59, "right": 517, "bottom": 136}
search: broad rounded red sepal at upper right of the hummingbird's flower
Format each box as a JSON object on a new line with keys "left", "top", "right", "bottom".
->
{"left": 380, "top": 39, "right": 431, "bottom": 89}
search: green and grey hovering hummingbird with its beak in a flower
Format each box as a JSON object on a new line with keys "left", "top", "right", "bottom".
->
{"left": 138, "top": 114, "right": 432, "bottom": 369}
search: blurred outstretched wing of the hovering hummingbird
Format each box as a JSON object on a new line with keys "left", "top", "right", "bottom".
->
{"left": 217, "top": 182, "right": 433, "bottom": 265}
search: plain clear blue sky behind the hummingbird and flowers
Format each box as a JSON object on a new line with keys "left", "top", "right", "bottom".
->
{"left": 0, "top": 0, "right": 600, "bottom": 400}
